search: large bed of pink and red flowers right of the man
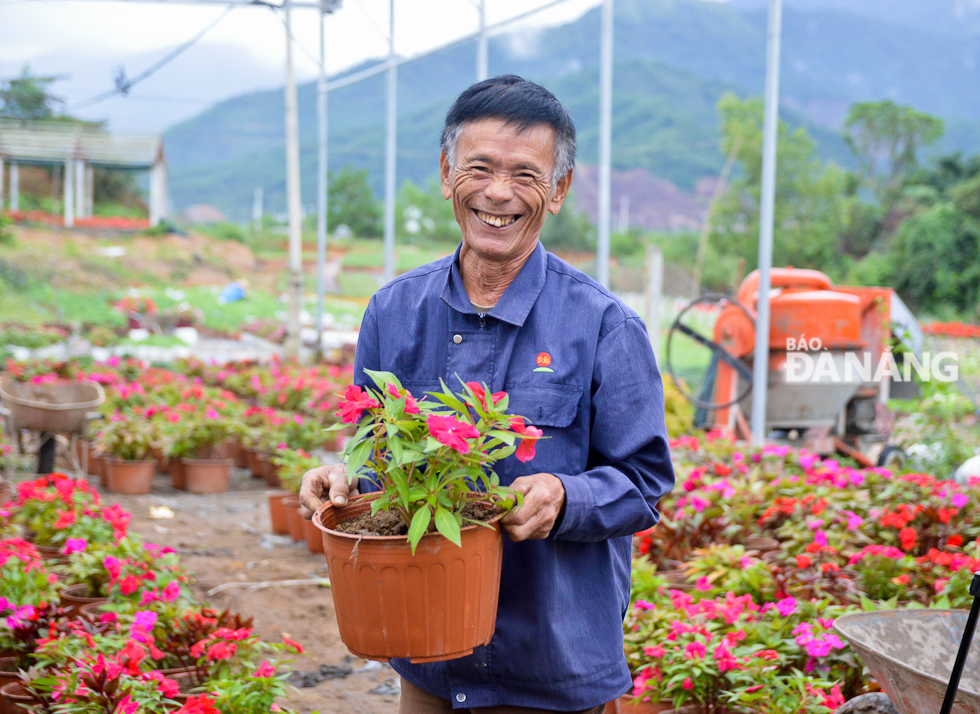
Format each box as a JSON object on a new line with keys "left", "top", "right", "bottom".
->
{"left": 624, "top": 433, "right": 980, "bottom": 714}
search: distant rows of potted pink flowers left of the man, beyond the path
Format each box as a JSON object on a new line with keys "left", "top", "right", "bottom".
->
{"left": 7, "top": 358, "right": 350, "bottom": 493}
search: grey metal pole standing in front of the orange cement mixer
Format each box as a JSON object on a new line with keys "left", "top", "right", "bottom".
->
{"left": 752, "top": 0, "right": 783, "bottom": 446}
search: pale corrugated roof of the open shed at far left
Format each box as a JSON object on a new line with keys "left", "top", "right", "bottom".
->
{"left": 0, "top": 124, "right": 163, "bottom": 168}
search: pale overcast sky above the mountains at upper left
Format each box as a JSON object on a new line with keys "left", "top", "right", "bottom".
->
{"left": 0, "top": 0, "right": 599, "bottom": 132}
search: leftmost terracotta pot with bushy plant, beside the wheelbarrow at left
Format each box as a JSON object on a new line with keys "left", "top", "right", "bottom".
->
{"left": 96, "top": 411, "right": 163, "bottom": 494}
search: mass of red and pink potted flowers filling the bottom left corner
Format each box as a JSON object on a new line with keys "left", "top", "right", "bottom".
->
{"left": 0, "top": 474, "right": 302, "bottom": 714}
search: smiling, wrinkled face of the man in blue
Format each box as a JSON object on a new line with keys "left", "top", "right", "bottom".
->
{"left": 440, "top": 119, "right": 572, "bottom": 262}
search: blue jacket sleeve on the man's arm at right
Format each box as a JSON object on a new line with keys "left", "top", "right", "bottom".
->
{"left": 551, "top": 316, "right": 674, "bottom": 541}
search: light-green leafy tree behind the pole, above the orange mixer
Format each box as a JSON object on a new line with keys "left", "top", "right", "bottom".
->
{"left": 709, "top": 92, "right": 849, "bottom": 276}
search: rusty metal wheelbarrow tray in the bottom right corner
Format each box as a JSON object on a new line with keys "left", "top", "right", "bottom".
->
{"left": 834, "top": 573, "right": 980, "bottom": 714}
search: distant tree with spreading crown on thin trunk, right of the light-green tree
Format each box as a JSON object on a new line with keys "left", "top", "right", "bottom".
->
{"left": 844, "top": 99, "right": 944, "bottom": 214}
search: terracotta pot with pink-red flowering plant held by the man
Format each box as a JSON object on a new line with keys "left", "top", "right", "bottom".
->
{"left": 314, "top": 370, "right": 541, "bottom": 661}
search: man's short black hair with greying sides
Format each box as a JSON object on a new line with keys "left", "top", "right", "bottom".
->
{"left": 441, "top": 74, "right": 575, "bottom": 185}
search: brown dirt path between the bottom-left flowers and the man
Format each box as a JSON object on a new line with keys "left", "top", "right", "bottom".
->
{"left": 103, "top": 469, "right": 398, "bottom": 714}
